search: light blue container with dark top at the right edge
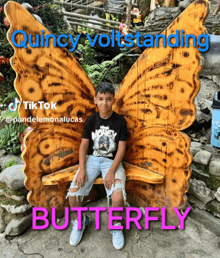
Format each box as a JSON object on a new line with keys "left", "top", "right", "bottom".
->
{"left": 211, "top": 91, "right": 220, "bottom": 148}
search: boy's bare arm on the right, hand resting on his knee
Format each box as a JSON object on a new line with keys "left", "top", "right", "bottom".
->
{"left": 103, "top": 141, "right": 126, "bottom": 190}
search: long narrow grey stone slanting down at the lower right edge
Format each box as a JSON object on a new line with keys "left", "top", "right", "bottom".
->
{"left": 189, "top": 209, "right": 220, "bottom": 236}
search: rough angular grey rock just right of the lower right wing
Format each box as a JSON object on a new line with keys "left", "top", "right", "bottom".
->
{"left": 188, "top": 179, "right": 214, "bottom": 204}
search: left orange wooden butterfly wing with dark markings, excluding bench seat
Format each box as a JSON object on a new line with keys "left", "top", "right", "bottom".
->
{"left": 5, "top": 2, "right": 96, "bottom": 209}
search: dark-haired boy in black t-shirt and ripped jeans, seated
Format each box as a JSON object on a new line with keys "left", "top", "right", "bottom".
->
{"left": 67, "top": 82, "right": 127, "bottom": 249}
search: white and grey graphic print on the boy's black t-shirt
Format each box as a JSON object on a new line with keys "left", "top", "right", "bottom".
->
{"left": 92, "top": 126, "right": 117, "bottom": 157}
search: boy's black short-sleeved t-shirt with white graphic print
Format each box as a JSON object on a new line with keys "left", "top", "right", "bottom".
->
{"left": 82, "top": 112, "right": 128, "bottom": 159}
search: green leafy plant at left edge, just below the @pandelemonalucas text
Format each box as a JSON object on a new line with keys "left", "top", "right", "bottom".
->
{"left": 0, "top": 123, "right": 27, "bottom": 155}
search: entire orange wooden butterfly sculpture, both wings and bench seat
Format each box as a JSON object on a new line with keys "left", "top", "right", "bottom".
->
{"left": 5, "top": 0, "right": 209, "bottom": 222}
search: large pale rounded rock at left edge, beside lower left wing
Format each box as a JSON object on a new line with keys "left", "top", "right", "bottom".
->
{"left": 0, "top": 165, "right": 25, "bottom": 190}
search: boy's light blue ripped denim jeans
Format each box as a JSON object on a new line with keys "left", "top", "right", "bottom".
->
{"left": 66, "top": 155, "right": 126, "bottom": 206}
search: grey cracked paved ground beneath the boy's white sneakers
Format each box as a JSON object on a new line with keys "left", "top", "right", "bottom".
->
{"left": 0, "top": 199, "right": 220, "bottom": 258}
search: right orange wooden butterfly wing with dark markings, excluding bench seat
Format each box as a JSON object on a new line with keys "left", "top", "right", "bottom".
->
{"left": 115, "top": 0, "right": 209, "bottom": 216}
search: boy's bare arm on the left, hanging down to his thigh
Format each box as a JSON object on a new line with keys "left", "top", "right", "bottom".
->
{"left": 75, "top": 138, "right": 89, "bottom": 188}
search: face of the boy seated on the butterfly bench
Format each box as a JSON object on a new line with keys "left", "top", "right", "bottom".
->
{"left": 94, "top": 92, "right": 115, "bottom": 114}
